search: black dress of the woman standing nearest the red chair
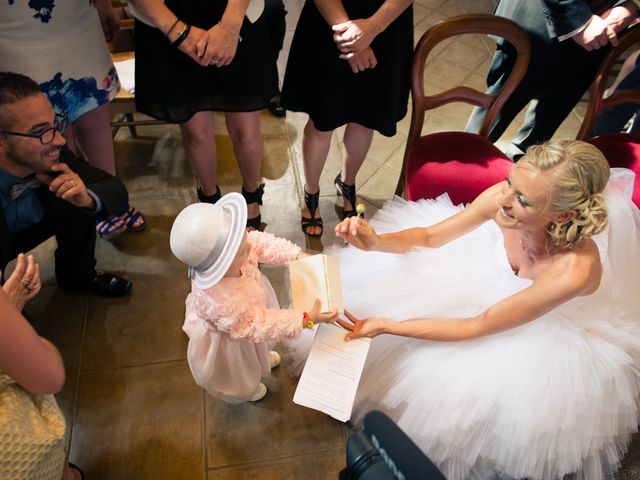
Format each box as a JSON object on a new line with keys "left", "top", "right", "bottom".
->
{"left": 282, "top": 0, "right": 413, "bottom": 136}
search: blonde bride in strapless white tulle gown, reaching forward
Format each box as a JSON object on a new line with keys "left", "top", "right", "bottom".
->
{"left": 336, "top": 141, "right": 640, "bottom": 480}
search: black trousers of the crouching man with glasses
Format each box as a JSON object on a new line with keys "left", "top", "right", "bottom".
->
{"left": 2, "top": 198, "right": 96, "bottom": 285}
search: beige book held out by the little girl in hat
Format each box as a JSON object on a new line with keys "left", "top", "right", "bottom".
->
{"left": 289, "top": 254, "right": 344, "bottom": 312}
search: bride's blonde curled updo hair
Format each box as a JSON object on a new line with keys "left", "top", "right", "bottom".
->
{"left": 523, "top": 140, "right": 609, "bottom": 248}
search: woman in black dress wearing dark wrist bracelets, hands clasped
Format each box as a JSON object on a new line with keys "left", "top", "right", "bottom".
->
{"left": 130, "top": 0, "right": 277, "bottom": 229}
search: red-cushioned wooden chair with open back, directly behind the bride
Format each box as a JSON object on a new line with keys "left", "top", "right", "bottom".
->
{"left": 396, "top": 14, "right": 531, "bottom": 204}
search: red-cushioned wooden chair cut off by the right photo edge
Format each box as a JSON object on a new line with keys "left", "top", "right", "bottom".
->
{"left": 577, "top": 26, "right": 640, "bottom": 207}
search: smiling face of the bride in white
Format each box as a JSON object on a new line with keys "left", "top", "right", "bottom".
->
{"left": 495, "top": 160, "right": 553, "bottom": 231}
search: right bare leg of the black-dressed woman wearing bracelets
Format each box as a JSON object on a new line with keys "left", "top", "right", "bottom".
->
{"left": 225, "top": 111, "right": 264, "bottom": 218}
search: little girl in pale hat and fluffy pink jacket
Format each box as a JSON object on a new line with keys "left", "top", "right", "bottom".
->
{"left": 170, "top": 193, "right": 338, "bottom": 403}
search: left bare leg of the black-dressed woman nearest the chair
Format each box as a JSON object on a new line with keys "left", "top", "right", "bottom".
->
{"left": 302, "top": 119, "right": 333, "bottom": 235}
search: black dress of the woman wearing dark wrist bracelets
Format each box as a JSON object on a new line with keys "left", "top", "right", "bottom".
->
{"left": 135, "top": 0, "right": 278, "bottom": 123}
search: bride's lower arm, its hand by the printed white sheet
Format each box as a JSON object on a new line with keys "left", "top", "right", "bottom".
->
{"left": 339, "top": 251, "right": 601, "bottom": 341}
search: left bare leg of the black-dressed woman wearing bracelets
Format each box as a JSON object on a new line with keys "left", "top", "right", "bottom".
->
{"left": 180, "top": 112, "right": 218, "bottom": 195}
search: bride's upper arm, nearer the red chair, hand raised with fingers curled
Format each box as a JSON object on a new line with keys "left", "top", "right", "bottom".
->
{"left": 336, "top": 182, "right": 504, "bottom": 253}
